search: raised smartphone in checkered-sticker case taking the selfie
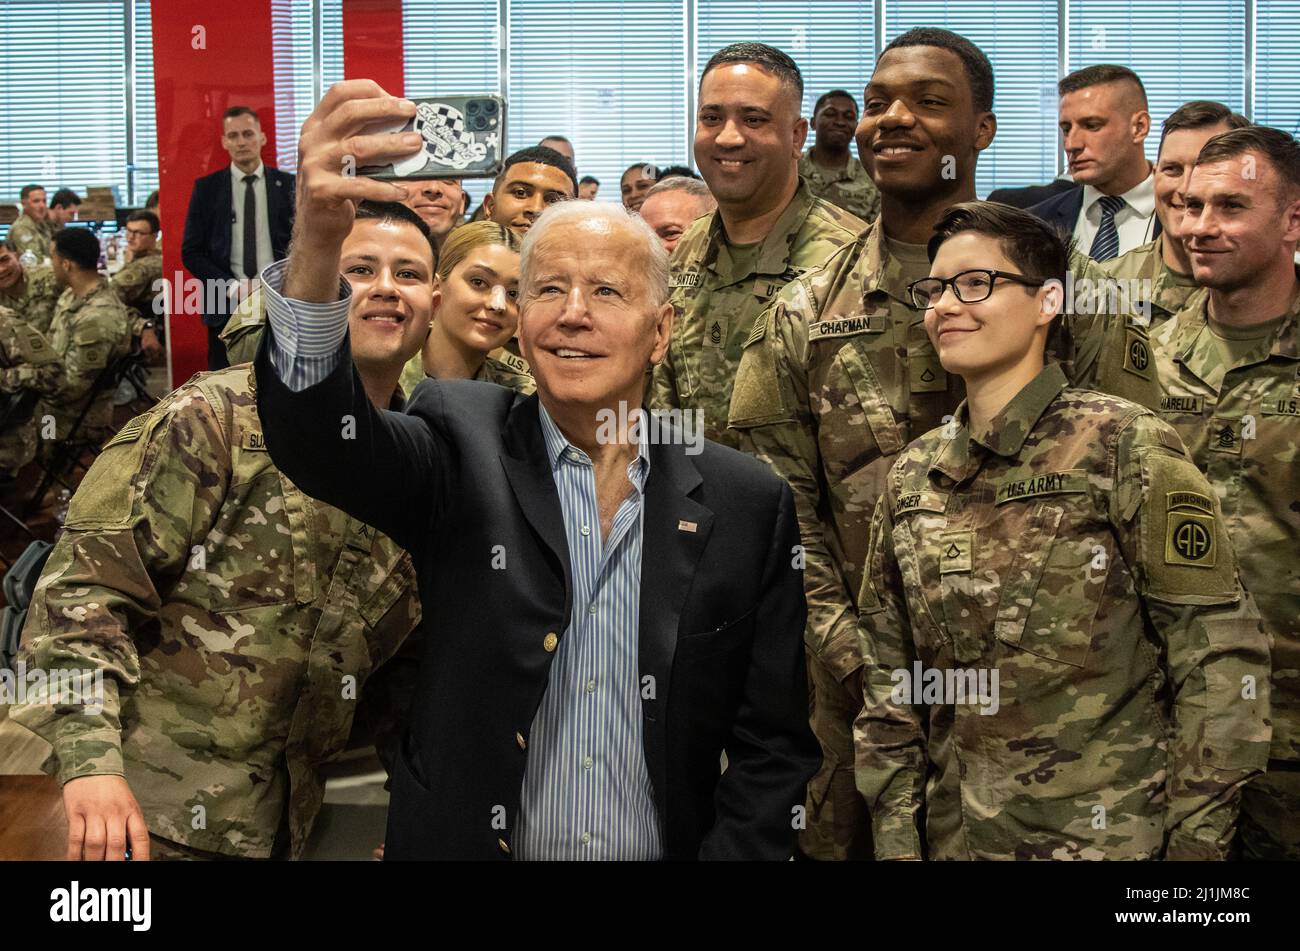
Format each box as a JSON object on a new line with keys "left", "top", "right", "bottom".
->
{"left": 356, "top": 96, "right": 506, "bottom": 179}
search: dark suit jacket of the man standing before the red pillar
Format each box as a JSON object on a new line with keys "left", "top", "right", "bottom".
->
{"left": 181, "top": 165, "right": 294, "bottom": 327}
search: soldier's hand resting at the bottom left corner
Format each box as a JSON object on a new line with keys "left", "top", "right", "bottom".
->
{"left": 64, "top": 776, "right": 150, "bottom": 861}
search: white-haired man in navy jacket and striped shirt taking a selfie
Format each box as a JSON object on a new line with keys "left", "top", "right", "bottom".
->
{"left": 256, "top": 81, "right": 819, "bottom": 860}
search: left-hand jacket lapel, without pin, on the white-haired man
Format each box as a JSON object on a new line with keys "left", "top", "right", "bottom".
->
{"left": 501, "top": 396, "right": 573, "bottom": 626}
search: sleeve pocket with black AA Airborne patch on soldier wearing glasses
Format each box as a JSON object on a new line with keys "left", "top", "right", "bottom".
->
{"left": 1138, "top": 450, "right": 1242, "bottom": 604}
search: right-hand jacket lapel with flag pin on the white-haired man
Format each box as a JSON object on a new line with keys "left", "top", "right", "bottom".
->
{"left": 638, "top": 433, "right": 714, "bottom": 816}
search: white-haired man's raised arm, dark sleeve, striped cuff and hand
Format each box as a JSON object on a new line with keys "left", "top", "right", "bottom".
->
{"left": 255, "top": 79, "right": 446, "bottom": 550}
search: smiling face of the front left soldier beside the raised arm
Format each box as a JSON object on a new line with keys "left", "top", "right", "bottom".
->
{"left": 341, "top": 218, "right": 433, "bottom": 372}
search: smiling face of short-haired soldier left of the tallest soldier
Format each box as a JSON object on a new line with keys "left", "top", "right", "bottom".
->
{"left": 694, "top": 62, "right": 809, "bottom": 213}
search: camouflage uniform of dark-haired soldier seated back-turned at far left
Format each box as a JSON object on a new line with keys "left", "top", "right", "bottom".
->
{"left": 36, "top": 281, "right": 131, "bottom": 440}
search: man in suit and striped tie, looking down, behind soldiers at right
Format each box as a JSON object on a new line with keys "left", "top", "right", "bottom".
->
{"left": 1024, "top": 64, "right": 1160, "bottom": 261}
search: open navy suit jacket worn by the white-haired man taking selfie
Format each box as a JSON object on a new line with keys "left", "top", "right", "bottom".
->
{"left": 255, "top": 327, "right": 822, "bottom": 860}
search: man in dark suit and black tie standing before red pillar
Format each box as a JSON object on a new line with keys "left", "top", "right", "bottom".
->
{"left": 181, "top": 105, "right": 294, "bottom": 370}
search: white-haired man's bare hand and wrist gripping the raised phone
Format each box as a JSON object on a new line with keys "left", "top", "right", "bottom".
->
{"left": 285, "top": 79, "right": 424, "bottom": 300}
